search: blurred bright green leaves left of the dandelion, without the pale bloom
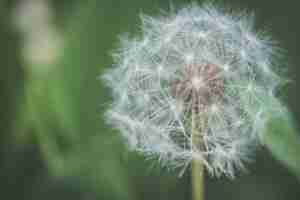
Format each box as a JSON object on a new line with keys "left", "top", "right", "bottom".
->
{"left": 23, "top": 0, "right": 130, "bottom": 199}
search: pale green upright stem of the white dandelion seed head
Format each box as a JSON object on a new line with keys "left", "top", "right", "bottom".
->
{"left": 191, "top": 112, "right": 204, "bottom": 200}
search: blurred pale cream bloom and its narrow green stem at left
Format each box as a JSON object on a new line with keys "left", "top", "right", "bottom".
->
{"left": 12, "top": 0, "right": 62, "bottom": 172}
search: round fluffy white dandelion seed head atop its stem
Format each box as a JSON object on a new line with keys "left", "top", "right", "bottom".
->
{"left": 103, "top": 4, "right": 280, "bottom": 177}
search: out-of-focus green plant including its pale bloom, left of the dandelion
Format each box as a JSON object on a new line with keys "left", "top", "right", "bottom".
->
{"left": 14, "top": 0, "right": 133, "bottom": 199}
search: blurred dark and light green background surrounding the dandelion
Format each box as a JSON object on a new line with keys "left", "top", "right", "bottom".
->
{"left": 0, "top": 0, "right": 300, "bottom": 200}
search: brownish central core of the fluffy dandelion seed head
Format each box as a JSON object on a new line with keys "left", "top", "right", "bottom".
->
{"left": 174, "top": 64, "right": 224, "bottom": 113}
